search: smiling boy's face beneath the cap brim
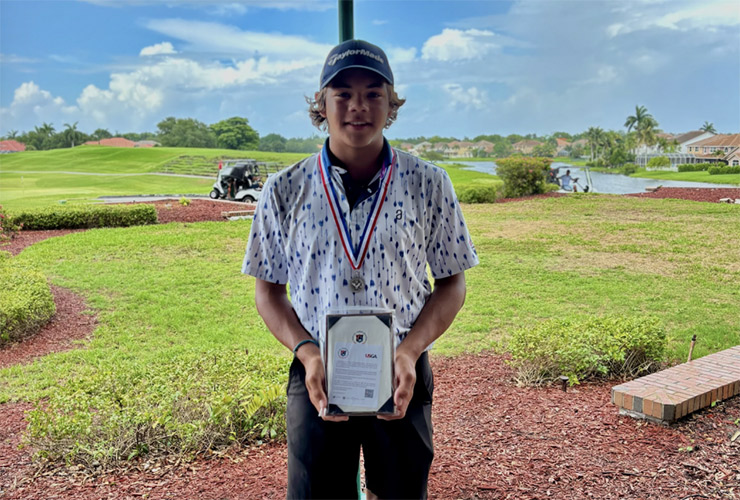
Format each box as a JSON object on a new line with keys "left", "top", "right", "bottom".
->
{"left": 321, "top": 68, "right": 391, "bottom": 158}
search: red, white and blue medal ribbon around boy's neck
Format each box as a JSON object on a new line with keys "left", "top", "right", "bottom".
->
{"left": 319, "top": 146, "right": 396, "bottom": 271}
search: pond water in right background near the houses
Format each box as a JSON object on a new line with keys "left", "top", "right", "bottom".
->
{"left": 456, "top": 161, "right": 738, "bottom": 194}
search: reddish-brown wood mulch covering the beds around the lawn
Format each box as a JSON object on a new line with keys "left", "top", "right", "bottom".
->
{"left": 0, "top": 194, "right": 740, "bottom": 500}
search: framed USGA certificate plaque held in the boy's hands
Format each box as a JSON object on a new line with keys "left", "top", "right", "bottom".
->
{"left": 323, "top": 312, "right": 395, "bottom": 416}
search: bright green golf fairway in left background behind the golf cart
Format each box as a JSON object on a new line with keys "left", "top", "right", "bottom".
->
{"left": 0, "top": 146, "right": 306, "bottom": 210}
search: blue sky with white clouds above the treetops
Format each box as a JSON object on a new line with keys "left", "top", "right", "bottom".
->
{"left": 0, "top": 0, "right": 740, "bottom": 139}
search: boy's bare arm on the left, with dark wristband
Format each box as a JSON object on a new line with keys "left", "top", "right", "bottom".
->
{"left": 255, "top": 279, "right": 348, "bottom": 421}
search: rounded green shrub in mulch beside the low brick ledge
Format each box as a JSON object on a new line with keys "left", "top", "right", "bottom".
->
{"left": 509, "top": 316, "right": 666, "bottom": 385}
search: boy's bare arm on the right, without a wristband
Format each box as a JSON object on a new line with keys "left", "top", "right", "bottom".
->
{"left": 378, "top": 271, "right": 465, "bottom": 420}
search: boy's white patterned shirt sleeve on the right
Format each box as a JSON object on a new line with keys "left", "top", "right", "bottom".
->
{"left": 427, "top": 169, "right": 479, "bottom": 279}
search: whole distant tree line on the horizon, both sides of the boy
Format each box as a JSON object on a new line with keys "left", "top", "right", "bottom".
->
{"left": 3, "top": 110, "right": 717, "bottom": 167}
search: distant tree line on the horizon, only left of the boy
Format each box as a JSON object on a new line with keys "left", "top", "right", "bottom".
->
{"left": 3, "top": 116, "right": 323, "bottom": 153}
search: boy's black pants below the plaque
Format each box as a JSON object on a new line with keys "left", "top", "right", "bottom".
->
{"left": 286, "top": 353, "right": 434, "bottom": 499}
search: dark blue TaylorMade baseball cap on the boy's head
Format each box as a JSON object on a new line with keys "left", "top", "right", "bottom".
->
{"left": 320, "top": 40, "right": 393, "bottom": 89}
